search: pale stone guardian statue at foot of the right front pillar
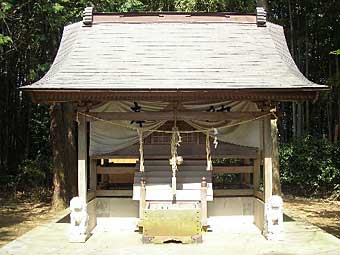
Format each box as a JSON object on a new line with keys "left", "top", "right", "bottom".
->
{"left": 263, "top": 196, "right": 284, "bottom": 241}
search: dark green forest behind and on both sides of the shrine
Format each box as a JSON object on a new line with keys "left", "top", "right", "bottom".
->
{"left": 0, "top": 0, "right": 340, "bottom": 206}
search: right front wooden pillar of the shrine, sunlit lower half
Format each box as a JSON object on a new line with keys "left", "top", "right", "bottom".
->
{"left": 263, "top": 116, "right": 273, "bottom": 202}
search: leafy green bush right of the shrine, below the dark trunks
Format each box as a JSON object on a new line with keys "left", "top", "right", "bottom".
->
{"left": 280, "top": 136, "right": 340, "bottom": 196}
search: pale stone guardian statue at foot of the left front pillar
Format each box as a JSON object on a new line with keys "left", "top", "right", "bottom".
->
{"left": 69, "top": 197, "right": 90, "bottom": 243}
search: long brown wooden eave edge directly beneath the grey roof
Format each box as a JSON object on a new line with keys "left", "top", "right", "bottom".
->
{"left": 28, "top": 88, "right": 327, "bottom": 102}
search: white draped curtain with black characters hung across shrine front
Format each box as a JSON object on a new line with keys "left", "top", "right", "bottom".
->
{"left": 90, "top": 101, "right": 261, "bottom": 156}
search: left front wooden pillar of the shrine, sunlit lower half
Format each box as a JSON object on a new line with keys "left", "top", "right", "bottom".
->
{"left": 78, "top": 115, "right": 87, "bottom": 203}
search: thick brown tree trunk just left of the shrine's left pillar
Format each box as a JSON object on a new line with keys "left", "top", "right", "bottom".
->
{"left": 50, "top": 103, "right": 77, "bottom": 210}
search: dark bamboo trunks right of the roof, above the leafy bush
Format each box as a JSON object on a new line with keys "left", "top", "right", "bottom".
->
{"left": 268, "top": 0, "right": 340, "bottom": 142}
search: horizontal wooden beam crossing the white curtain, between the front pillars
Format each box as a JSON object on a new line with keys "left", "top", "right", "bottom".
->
{"left": 80, "top": 111, "right": 266, "bottom": 121}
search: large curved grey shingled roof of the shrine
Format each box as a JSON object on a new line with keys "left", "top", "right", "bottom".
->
{"left": 22, "top": 11, "right": 325, "bottom": 101}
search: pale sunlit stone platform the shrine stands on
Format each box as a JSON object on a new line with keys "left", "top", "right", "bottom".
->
{"left": 0, "top": 208, "right": 340, "bottom": 255}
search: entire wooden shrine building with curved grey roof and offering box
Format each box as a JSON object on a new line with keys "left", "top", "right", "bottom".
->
{"left": 22, "top": 8, "right": 326, "bottom": 242}
